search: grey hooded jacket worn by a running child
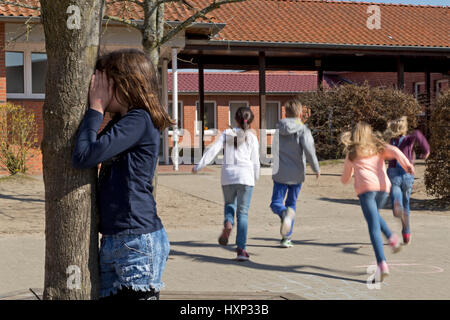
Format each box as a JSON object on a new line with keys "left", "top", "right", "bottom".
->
{"left": 272, "top": 118, "right": 320, "bottom": 184}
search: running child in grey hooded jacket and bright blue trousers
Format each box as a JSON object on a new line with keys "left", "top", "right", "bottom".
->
{"left": 270, "top": 99, "right": 320, "bottom": 248}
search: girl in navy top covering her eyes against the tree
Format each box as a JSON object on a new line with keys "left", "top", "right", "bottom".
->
{"left": 72, "top": 49, "right": 173, "bottom": 300}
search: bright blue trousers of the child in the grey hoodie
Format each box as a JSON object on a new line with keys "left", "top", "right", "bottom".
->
{"left": 270, "top": 181, "right": 302, "bottom": 238}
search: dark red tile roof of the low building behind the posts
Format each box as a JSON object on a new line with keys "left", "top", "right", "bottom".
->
{"left": 168, "top": 72, "right": 328, "bottom": 93}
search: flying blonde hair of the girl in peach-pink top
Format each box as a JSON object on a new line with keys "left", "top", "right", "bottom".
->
{"left": 341, "top": 122, "right": 386, "bottom": 161}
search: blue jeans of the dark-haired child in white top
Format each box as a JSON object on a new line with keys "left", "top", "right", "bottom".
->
{"left": 222, "top": 184, "right": 253, "bottom": 249}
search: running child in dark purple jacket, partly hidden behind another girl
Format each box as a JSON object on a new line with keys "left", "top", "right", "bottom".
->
{"left": 385, "top": 116, "right": 430, "bottom": 244}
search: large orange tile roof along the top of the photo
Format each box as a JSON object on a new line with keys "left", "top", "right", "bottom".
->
{"left": 0, "top": 0, "right": 450, "bottom": 48}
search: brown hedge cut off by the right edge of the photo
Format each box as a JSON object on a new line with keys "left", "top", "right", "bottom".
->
{"left": 425, "top": 89, "right": 450, "bottom": 202}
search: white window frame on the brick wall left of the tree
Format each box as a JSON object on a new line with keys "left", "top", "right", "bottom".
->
{"left": 4, "top": 43, "right": 47, "bottom": 100}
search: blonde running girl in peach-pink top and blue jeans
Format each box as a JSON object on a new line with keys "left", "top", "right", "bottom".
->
{"left": 341, "top": 122, "right": 414, "bottom": 281}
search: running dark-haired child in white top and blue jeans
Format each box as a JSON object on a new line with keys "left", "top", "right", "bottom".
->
{"left": 192, "top": 107, "right": 260, "bottom": 261}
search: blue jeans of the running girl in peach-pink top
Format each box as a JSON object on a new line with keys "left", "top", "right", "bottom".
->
{"left": 358, "top": 191, "right": 392, "bottom": 263}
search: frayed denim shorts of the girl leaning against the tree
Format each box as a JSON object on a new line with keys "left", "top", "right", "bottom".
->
{"left": 100, "top": 228, "right": 170, "bottom": 298}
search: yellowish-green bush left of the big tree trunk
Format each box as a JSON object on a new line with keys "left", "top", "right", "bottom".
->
{"left": 0, "top": 104, "right": 37, "bottom": 174}
